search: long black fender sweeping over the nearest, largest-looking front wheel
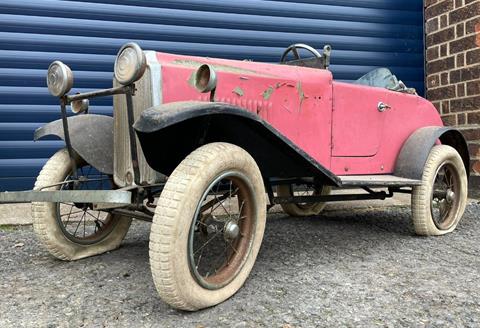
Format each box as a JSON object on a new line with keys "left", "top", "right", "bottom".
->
{"left": 134, "top": 102, "right": 340, "bottom": 185}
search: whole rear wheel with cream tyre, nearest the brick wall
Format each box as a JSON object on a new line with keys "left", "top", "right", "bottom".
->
{"left": 412, "top": 145, "right": 468, "bottom": 236}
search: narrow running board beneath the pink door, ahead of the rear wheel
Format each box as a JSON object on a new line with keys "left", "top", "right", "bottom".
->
{"left": 338, "top": 174, "right": 422, "bottom": 187}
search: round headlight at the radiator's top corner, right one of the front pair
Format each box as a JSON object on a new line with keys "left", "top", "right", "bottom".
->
{"left": 114, "top": 42, "right": 147, "bottom": 85}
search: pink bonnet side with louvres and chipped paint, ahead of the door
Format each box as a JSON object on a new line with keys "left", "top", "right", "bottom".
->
{"left": 157, "top": 53, "right": 332, "bottom": 168}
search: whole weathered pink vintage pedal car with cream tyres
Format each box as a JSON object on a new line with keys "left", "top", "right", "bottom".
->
{"left": 0, "top": 43, "right": 469, "bottom": 310}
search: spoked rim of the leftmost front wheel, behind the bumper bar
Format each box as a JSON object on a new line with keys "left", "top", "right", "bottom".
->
{"left": 56, "top": 165, "right": 117, "bottom": 245}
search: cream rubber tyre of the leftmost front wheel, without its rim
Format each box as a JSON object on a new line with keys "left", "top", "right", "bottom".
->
{"left": 32, "top": 149, "right": 132, "bottom": 261}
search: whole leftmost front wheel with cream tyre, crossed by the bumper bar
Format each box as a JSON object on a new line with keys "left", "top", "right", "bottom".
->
{"left": 32, "top": 149, "right": 131, "bottom": 261}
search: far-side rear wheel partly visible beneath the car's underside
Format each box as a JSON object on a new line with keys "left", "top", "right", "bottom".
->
{"left": 277, "top": 185, "right": 332, "bottom": 217}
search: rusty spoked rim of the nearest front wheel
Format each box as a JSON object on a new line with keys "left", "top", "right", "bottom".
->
{"left": 188, "top": 171, "right": 256, "bottom": 289}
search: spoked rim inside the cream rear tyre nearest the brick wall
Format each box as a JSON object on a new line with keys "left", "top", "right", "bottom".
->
{"left": 430, "top": 161, "right": 460, "bottom": 230}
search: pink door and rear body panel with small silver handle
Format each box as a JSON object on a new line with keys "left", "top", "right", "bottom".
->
{"left": 331, "top": 82, "right": 443, "bottom": 175}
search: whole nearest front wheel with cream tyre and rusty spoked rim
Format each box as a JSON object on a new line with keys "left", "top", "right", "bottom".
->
{"left": 150, "top": 143, "right": 266, "bottom": 311}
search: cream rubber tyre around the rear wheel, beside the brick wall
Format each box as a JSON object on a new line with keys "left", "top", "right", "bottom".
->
{"left": 412, "top": 145, "right": 468, "bottom": 236}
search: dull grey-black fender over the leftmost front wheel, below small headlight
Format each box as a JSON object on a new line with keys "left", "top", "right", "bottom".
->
{"left": 34, "top": 114, "right": 113, "bottom": 174}
